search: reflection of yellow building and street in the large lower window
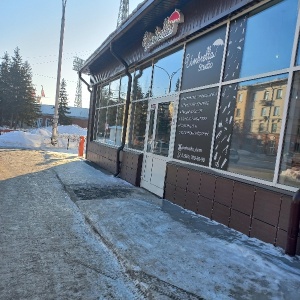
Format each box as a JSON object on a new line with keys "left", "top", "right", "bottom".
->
{"left": 218, "top": 74, "right": 287, "bottom": 181}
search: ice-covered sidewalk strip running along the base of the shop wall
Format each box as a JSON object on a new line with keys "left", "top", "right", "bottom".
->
{"left": 56, "top": 154, "right": 300, "bottom": 299}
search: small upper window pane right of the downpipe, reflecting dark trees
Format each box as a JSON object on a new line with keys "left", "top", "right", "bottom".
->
{"left": 132, "top": 66, "right": 152, "bottom": 100}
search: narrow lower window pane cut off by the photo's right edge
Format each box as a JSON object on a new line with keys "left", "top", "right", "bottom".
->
{"left": 279, "top": 72, "right": 300, "bottom": 187}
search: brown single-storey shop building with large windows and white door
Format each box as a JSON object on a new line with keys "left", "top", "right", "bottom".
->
{"left": 80, "top": 0, "right": 300, "bottom": 253}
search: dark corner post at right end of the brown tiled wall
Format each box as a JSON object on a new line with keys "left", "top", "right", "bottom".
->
{"left": 285, "top": 190, "right": 300, "bottom": 256}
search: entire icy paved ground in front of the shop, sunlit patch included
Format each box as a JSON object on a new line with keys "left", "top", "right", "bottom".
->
{"left": 0, "top": 150, "right": 300, "bottom": 300}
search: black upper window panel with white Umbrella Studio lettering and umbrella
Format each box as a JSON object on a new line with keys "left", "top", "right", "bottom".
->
{"left": 181, "top": 26, "right": 226, "bottom": 90}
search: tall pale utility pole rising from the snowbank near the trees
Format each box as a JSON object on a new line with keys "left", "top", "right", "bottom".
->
{"left": 51, "top": 0, "right": 67, "bottom": 146}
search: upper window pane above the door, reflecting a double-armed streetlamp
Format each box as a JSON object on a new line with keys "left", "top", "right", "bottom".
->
{"left": 152, "top": 49, "right": 183, "bottom": 97}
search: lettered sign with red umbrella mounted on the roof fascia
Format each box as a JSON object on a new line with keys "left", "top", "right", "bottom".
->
{"left": 142, "top": 9, "right": 184, "bottom": 51}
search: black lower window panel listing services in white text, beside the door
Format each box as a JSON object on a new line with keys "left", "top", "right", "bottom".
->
{"left": 174, "top": 88, "right": 218, "bottom": 166}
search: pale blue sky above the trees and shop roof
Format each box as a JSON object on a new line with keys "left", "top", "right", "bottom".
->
{"left": 0, "top": 0, "right": 142, "bottom": 107}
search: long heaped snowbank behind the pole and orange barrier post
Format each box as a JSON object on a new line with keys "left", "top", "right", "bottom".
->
{"left": 0, "top": 125, "right": 87, "bottom": 153}
